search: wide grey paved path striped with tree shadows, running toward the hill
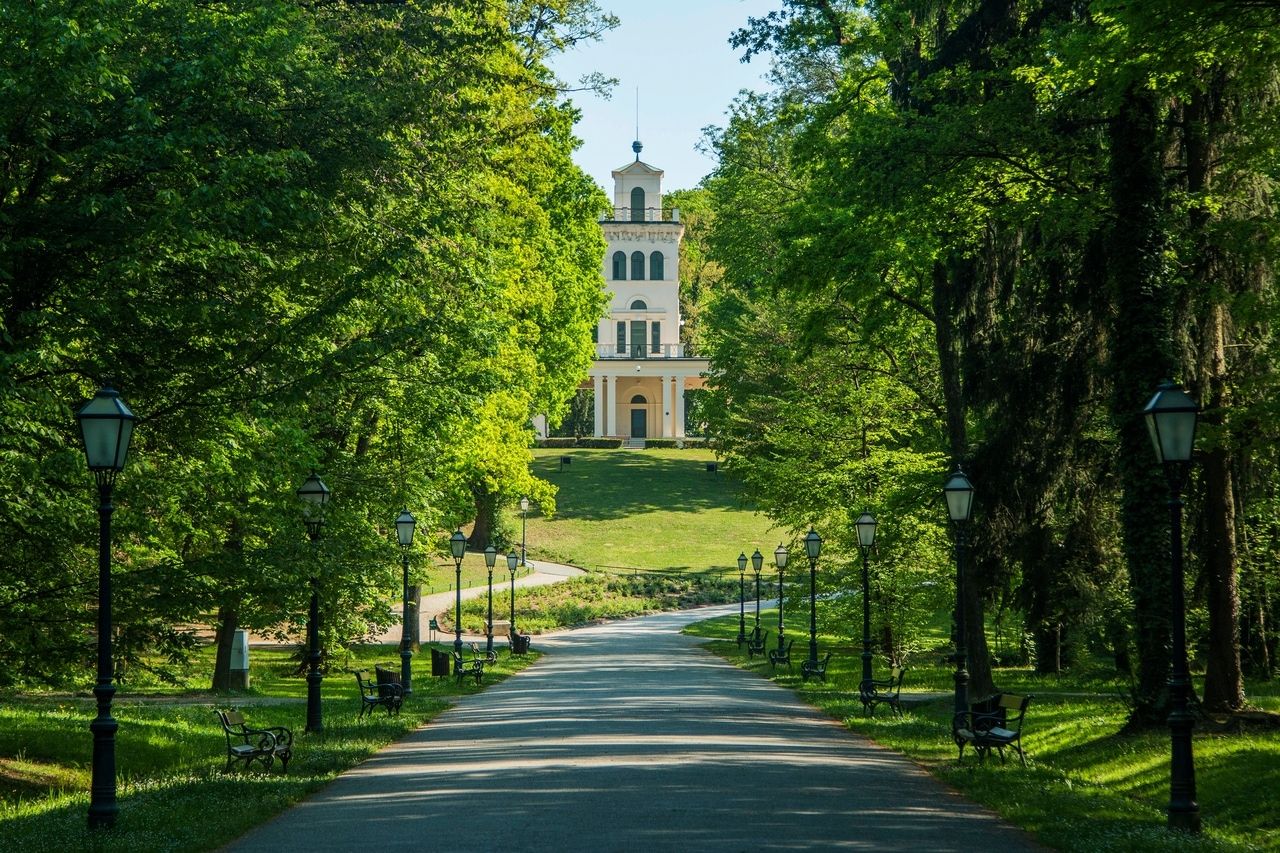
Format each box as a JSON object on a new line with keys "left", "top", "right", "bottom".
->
{"left": 228, "top": 607, "right": 1041, "bottom": 853}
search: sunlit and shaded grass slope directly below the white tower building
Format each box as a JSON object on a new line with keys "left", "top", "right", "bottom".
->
{"left": 513, "top": 447, "right": 782, "bottom": 571}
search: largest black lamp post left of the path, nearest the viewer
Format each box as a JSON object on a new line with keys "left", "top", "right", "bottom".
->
{"left": 76, "top": 388, "right": 136, "bottom": 829}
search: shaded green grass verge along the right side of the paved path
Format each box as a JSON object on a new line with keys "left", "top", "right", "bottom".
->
{"left": 687, "top": 613, "right": 1280, "bottom": 852}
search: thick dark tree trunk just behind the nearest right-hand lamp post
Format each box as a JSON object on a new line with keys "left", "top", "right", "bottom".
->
{"left": 1107, "top": 85, "right": 1172, "bottom": 725}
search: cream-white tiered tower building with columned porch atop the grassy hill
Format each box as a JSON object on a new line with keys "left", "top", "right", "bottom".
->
{"left": 584, "top": 142, "right": 708, "bottom": 439}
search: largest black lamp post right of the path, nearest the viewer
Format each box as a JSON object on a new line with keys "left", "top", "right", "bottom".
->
{"left": 1143, "top": 382, "right": 1201, "bottom": 834}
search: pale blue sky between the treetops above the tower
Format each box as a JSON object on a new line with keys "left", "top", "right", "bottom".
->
{"left": 552, "top": 0, "right": 782, "bottom": 192}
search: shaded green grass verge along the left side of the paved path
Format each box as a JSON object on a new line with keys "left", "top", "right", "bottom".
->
{"left": 0, "top": 647, "right": 536, "bottom": 853}
